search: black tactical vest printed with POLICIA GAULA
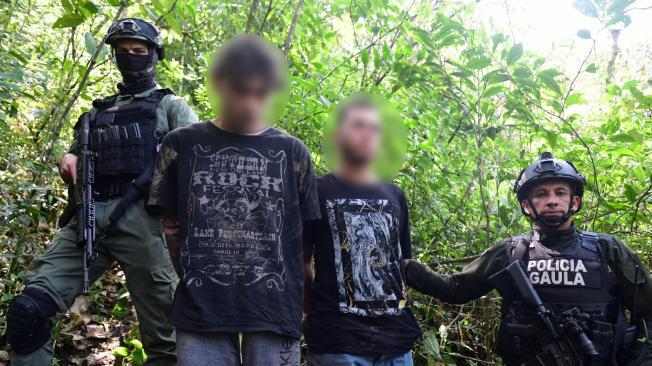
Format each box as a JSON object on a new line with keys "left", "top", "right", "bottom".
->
{"left": 497, "top": 232, "right": 624, "bottom": 365}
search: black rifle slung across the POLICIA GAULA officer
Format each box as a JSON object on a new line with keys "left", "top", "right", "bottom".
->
{"left": 491, "top": 260, "right": 598, "bottom": 366}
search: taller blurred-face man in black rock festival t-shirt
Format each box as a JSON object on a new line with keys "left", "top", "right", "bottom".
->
{"left": 150, "top": 36, "right": 320, "bottom": 366}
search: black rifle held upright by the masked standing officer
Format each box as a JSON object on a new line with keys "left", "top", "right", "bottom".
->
{"left": 74, "top": 113, "right": 95, "bottom": 295}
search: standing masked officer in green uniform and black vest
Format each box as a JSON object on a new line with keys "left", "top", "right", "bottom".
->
{"left": 7, "top": 18, "right": 197, "bottom": 366}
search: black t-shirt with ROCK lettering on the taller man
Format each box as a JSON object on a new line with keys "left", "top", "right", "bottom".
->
{"left": 149, "top": 122, "right": 320, "bottom": 338}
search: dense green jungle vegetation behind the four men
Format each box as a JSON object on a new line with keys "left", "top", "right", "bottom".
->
{"left": 0, "top": 0, "right": 652, "bottom": 365}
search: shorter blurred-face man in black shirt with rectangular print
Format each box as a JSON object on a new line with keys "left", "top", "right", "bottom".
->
{"left": 303, "top": 97, "right": 420, "bottom": 366}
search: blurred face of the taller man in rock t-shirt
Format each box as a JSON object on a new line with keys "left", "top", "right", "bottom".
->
{"left": 215, "top": 77, "right": 272, "bottom": 124}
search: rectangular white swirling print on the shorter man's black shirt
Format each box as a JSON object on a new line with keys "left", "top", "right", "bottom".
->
{"left": 326, "top": 198, "right": 406, "bottom": 316}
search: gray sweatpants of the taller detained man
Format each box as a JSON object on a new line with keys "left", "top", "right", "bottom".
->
{"left": 177, "top": 330, "right": 301, "bottom": 366}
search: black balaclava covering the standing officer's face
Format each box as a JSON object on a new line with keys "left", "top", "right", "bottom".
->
{"left": 115, "top": 48, "right": 158, "bottom": 94}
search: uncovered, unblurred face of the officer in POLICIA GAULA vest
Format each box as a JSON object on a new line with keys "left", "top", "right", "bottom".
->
{"left": 521, "top": 181, "right": 580, "bottom": 226}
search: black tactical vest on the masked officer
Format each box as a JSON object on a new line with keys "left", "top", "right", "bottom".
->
{"left": 90, "top": 89, "right": 173, "bottom": 199}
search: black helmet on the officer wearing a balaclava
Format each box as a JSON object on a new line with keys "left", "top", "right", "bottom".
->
{"left": 105, "top": 18, "right": 164, "bottom": 60}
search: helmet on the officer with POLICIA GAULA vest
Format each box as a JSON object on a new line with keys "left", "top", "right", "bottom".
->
{"left": 514, "top": 152, "right": 586, "bottom": 223}
